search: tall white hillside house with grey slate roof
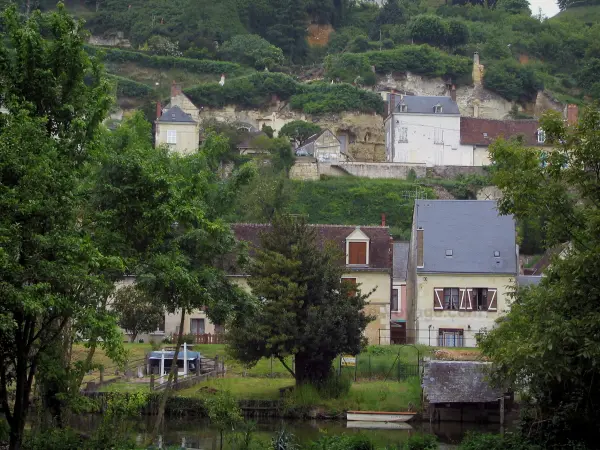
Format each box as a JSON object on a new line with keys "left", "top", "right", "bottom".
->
{"left": 385, "top": 95, "right": 472, "bottom": 167}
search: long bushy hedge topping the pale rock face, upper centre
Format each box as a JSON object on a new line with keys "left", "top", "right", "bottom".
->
{"left": 185, "top": 73, "right": 383, "bottom": 114}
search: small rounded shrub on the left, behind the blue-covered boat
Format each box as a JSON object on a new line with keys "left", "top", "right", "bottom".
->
{"left": 112, "top": 285, "right": 165, "bottom": 342}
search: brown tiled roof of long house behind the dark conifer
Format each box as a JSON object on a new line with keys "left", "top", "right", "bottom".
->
{"left": 230, "top": 223, "right": 392, "bottom": 275}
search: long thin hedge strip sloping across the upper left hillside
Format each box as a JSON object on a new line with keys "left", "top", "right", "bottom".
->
{"left": 86, "top": 45, "right": 242, "bottom": 74}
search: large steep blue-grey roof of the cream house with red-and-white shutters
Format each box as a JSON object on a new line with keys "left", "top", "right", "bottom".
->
{"left": 415, "top": 200, "right": 517, "bottom": 274}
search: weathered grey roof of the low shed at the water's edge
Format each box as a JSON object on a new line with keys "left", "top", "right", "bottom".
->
{"left": 423, "top": 361, "right": 502, "bottom": 403}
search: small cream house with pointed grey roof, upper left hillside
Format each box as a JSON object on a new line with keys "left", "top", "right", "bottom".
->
{"left": 155, "top": 106, "right": 200, "bottom": 154}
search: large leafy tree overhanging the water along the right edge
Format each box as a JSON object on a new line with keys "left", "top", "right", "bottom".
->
{"left": 480, "top": 107, "right": 600, "bottom": 448}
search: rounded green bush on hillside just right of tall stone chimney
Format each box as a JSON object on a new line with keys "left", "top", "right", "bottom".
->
{"left": 483, "top": 59, "right": 544, "bottom": 101}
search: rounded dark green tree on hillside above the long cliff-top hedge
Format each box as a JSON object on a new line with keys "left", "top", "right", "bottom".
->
{"left": 219, "top": 34, "right": 284, "bottom": 69}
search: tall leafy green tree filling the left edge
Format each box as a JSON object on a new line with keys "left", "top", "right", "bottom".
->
{"left": 0, "top": 4, "right": 115, "bottom": 449}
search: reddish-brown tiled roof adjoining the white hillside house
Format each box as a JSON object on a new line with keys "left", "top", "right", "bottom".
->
{"left": 460, "top": 117, "right": 542, "bottom": 145}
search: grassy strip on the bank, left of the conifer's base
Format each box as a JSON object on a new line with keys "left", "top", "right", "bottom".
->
{"left": 177, "top": 377, "right": 294, "bottom": 400}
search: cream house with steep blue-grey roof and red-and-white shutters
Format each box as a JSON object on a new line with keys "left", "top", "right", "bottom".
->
{"left": 407, "top": 200, "right": 518, "bottom": 347}
